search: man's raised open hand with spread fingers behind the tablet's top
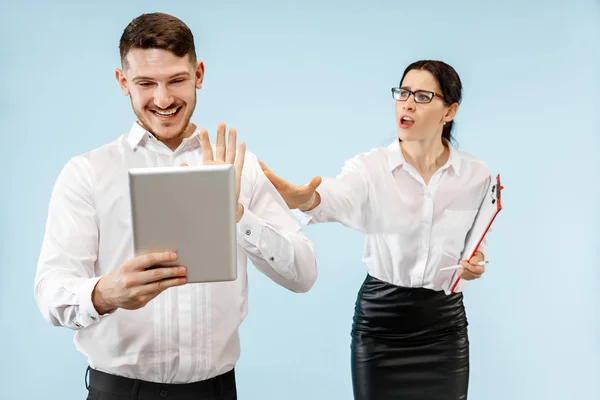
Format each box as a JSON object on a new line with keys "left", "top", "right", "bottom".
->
{"left": 200, "top": 123, "right": 246, "bottom": 222}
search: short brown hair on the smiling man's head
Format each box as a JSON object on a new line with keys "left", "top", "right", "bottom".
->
{"left": 119, "top": 13, "right": 196, "bottom": 65}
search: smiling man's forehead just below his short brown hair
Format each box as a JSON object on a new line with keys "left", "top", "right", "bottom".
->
{"left": 125, "top": 49, "right": 193, "bottom": 79}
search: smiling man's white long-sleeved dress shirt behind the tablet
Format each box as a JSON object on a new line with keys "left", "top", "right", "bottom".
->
{"left": 34, "top": 123, "right": 317, "bottom": 383}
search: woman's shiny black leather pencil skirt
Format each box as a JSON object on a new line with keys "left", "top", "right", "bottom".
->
{"left": 351, "top": 275, "right": 469, "bottom": 400}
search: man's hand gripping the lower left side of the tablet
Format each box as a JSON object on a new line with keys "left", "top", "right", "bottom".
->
{"left": 92, "top": 252, "right": 187, "bottom": 315}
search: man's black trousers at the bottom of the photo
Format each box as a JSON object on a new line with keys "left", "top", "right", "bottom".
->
{"left": 86, "top": 368, "right": 237, "bottom": 400}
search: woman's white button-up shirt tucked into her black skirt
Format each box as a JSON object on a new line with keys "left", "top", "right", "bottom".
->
{"left": 294, "top": 140, "right": 490, "bottom": 293}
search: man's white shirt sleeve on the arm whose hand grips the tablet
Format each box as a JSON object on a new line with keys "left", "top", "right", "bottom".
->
{"left": 34, "top": 158, "right": 105, "bottom": 329}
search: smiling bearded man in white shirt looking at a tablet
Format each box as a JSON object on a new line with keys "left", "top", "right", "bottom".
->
{"left": 35, "top": 13, "right": 317, "bottom": 399}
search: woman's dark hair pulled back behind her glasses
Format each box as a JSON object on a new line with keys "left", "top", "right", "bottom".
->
{"left": 399, "top": 60, "right": 462, "bottom": 145}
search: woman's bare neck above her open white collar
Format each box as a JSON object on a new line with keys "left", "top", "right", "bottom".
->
{"left": 400, "top": 137, "right": 450, "bottom": 175}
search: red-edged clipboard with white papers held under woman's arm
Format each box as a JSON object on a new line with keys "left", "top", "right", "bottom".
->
{"left": 450, "top": 174, "right": 504, "bottom": 293}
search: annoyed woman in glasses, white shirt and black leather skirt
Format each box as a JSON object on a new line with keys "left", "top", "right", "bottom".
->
{"left": 262, "top": 61, "right": 490, "bottom": 400}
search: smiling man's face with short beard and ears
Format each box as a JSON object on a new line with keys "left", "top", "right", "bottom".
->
{"left": 116, "top": 49, "right": 204, "bottom": 149}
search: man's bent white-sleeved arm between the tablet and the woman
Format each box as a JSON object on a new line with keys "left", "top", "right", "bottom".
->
{"left": 237, "top": 153, "right": 317, "bottom": 292}
